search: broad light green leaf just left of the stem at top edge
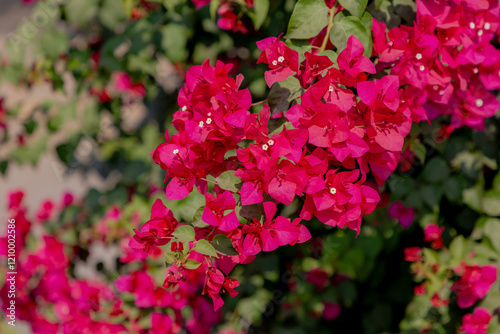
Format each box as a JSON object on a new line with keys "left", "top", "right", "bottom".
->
{"left": 285, "top": 0, "right": 329, "bottom": 39}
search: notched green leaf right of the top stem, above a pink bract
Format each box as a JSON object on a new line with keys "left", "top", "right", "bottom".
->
{"left": 330, "top": 16, "right": 373, "bottom": 57}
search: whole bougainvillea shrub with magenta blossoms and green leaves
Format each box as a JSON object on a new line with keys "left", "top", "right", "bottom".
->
{"left": 0, "top": 0, "right": 500, "bottom": 334}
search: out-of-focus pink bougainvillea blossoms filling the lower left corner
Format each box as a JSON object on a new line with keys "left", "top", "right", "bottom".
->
{"left": 0, "top": 191, "right": 223, "bottom": 334}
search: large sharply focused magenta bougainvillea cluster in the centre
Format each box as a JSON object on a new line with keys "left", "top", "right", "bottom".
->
{"left": 131, "top": 30, "right": 422, "bottom": 307}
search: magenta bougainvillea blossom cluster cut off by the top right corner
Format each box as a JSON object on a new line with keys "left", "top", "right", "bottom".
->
{"left": 372, "top": 0, "right": 500, "bottom": 130}
